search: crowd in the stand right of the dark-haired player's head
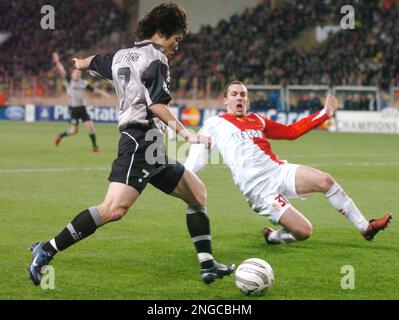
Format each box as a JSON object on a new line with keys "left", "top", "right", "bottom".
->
{"left": 172, "top": 0, "right": 399, "bottom": 91}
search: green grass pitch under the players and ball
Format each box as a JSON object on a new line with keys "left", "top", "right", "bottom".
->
{"left": 0, "top": 122, "right": 399, "bottom": 300}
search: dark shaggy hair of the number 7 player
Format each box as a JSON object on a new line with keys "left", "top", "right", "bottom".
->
{"left": 136, "top": 3, "right": 188, "bottom": 40}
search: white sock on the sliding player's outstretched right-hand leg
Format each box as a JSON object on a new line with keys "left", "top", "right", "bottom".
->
{"left": 326, "top": 183, "right": 369, "bottom": 233}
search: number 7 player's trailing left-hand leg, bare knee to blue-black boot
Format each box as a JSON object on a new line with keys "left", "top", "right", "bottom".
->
{"left": 29, "top": 182, "right": 140, "bottom": 285}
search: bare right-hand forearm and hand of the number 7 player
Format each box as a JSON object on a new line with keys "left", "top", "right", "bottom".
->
{"left": 150, "top": 104, "right": 212, "bottom": 149}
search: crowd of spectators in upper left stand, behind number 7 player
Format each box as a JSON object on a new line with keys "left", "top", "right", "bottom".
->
{"left": 0, "top": 0, "right": 128, "bottom": 89}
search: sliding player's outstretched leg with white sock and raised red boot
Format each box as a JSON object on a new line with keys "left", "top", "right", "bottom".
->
{"left": 295, "top": 166, "right": 391, "bottom": 240}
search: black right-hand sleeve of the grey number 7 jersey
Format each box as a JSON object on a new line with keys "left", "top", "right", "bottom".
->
{"left": 141, "top": 60, "right": 172, "bottom": 107}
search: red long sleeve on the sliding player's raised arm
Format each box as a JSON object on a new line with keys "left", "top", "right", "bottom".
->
{"left": 264, "top": 110, "right": 329, "bottom": 140}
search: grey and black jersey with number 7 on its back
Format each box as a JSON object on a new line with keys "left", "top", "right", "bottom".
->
{"left": 89, "top": 40, "right": 171, "bottom": 130}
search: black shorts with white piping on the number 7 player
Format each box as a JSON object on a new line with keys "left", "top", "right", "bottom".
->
{"left": 108, "top": 128, "right": 185, "bottom": 194}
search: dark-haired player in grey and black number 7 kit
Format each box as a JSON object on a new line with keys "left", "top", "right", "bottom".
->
{"left": 29, "top": 4, "right": 235, "bottom": 285}
